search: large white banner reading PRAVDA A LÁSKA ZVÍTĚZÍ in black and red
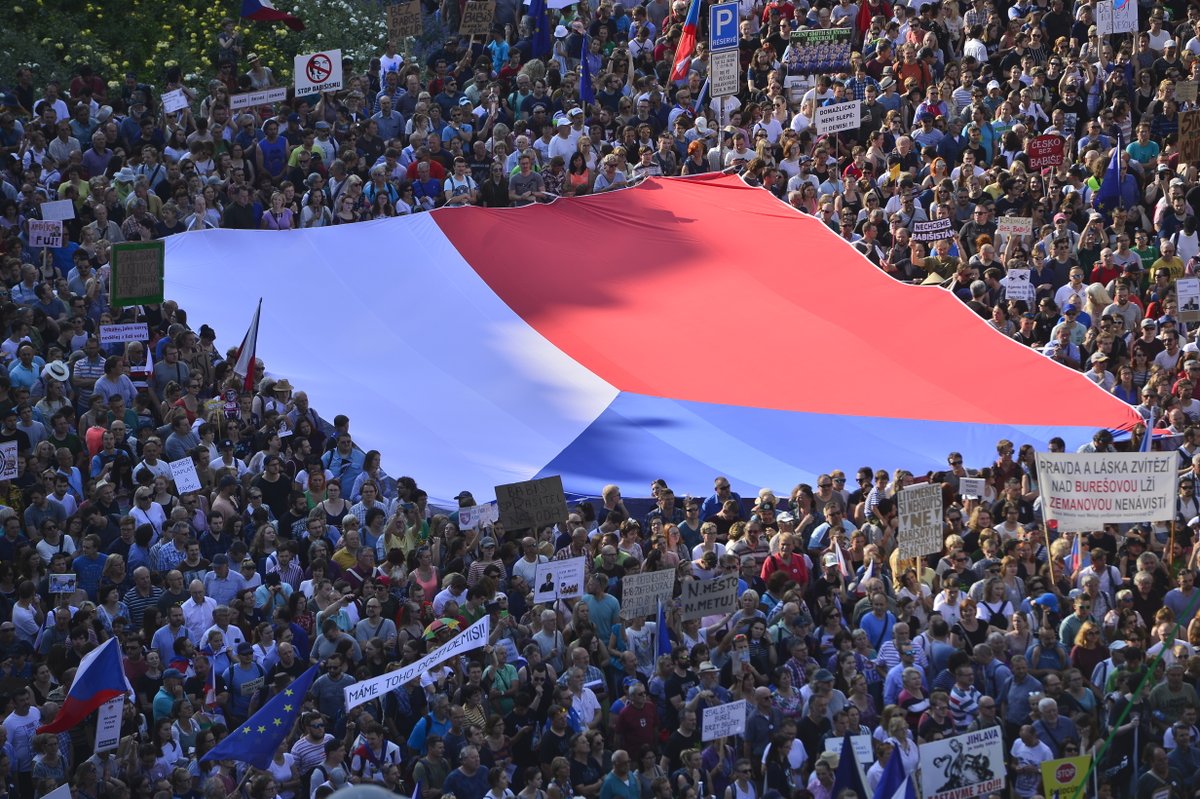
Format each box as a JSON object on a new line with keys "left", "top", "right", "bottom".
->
{"left": 1038, "top": 452, "right": 1178, "bottom": 533}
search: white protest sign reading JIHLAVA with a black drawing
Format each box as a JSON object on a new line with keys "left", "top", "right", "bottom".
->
{"left": 919, "top": 727, "right": 1007, "bottom": 799}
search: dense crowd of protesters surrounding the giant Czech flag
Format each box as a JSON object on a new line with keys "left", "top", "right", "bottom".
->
{"left": 0, "top": 0, "right": 1200, "bottom": 799}
